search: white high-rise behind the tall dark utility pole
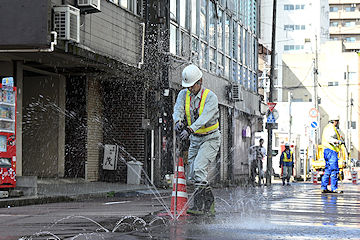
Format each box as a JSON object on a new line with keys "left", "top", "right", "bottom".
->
{"left": 260, "top": 0, "right": 329, "bottom": 102}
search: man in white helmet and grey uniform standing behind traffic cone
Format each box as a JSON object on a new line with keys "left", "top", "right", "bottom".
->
{"left": 173, "top": 64, "right": 220, "bottom": 215}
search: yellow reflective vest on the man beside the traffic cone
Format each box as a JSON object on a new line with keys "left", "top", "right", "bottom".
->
{"left": 185, "top": 89, "right": 219, "bottom": 134}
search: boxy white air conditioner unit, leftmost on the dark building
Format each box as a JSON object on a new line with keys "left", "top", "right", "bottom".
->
{"left": 54, "top": 5, "right": 80, "bottom": 43}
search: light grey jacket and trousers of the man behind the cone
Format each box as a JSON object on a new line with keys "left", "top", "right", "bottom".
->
{"left": 173, "top": 86, "right": 221, "bottom": 182}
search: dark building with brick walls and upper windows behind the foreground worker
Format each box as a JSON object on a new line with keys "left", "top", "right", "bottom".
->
{"left": 0, "top": 0, "right": 263, "bottom": 188}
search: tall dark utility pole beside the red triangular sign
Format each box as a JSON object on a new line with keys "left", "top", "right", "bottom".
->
{"left": 266, "top": 0, "right": 276, "bottom": 186}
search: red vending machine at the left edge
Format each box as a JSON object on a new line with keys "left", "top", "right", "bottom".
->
{"left": 0, "top": 77, "right": 17, "bottom": 191}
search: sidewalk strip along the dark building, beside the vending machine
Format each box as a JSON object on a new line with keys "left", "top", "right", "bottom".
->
{"left": 0, "top": 178, "right": 172, "bottom": 208}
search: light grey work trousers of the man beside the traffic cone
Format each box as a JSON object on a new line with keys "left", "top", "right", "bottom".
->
{"left": 188, "top": 131, "right": 221, "bottom": 182}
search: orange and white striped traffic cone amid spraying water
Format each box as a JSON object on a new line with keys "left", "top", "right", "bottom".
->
{"left": 170, "top": 157, "right": 188, "bottom": 216}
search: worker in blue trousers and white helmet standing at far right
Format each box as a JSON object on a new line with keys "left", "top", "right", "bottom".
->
{"left": 321, "top": 114, "right": 344, "bottom": 193}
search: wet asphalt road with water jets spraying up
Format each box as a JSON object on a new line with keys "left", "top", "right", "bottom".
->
{"left": 0, "top": 183, "right": 360, "bottom": 240}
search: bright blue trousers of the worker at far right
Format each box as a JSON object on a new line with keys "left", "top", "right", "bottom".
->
{"left": 321, "top": 148, "right": 339, "bottom": 191}
